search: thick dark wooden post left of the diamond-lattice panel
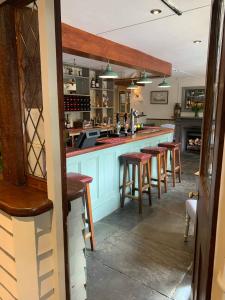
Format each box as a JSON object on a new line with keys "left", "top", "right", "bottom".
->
{"left": 0, "top": 4, "right": 26, "bottom": 185}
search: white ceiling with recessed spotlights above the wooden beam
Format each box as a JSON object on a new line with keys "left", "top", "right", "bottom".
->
{"left": 61, "top": 0, "right": 211, "bottom": 77}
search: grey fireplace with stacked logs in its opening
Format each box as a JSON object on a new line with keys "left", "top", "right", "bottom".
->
{"left": 175, "top": 117, "right": 202, "bottom": 152}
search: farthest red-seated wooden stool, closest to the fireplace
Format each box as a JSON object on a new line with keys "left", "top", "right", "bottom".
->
{"left": 159, "top": 142, "right": 181, "bottom": 187}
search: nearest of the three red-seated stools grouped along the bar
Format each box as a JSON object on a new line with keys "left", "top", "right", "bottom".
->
{"left": 120, "top": 152, "right": 152, "bottom": 214}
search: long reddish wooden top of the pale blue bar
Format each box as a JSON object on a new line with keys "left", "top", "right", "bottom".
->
{"left": 66, "top": 127, "right": 174, "bottom": 158}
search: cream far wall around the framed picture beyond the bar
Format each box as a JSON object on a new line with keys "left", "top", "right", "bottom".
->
{"left": 132, "top": 76, "right": 205, "bottom": 121}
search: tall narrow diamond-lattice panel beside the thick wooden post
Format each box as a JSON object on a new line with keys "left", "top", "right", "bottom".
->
{"left": 16, "top": 2, "right": 46, "bottom": 178}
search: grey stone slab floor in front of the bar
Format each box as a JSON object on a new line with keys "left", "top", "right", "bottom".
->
{"left": 87, "top": 154, "right": 199, "bottom": 300}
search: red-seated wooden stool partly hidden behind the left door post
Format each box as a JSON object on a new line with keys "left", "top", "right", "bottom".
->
{"left": 67, "top": 173, "right": 96, "bottom": 251}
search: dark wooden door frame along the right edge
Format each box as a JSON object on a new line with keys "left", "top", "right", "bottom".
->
{"left": 192, "top": 0, "right": 225, "bottom": 300}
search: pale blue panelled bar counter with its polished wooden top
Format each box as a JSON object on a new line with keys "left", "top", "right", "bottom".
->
{"left": 67, "top": 127, "right": 174, "bottom": 222}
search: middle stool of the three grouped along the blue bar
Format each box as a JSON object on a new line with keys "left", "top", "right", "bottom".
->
{"left": 141, "top": 147, "right": 167, "bottom": 199}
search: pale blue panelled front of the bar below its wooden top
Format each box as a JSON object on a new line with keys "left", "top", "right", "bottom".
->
{"left": 67, "top": 131, "right": 173, "bottom": 222}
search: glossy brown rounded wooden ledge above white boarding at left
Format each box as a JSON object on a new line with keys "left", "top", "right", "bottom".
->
{"left": 0, "top": 180, "right": 53, "bottom": 217}
